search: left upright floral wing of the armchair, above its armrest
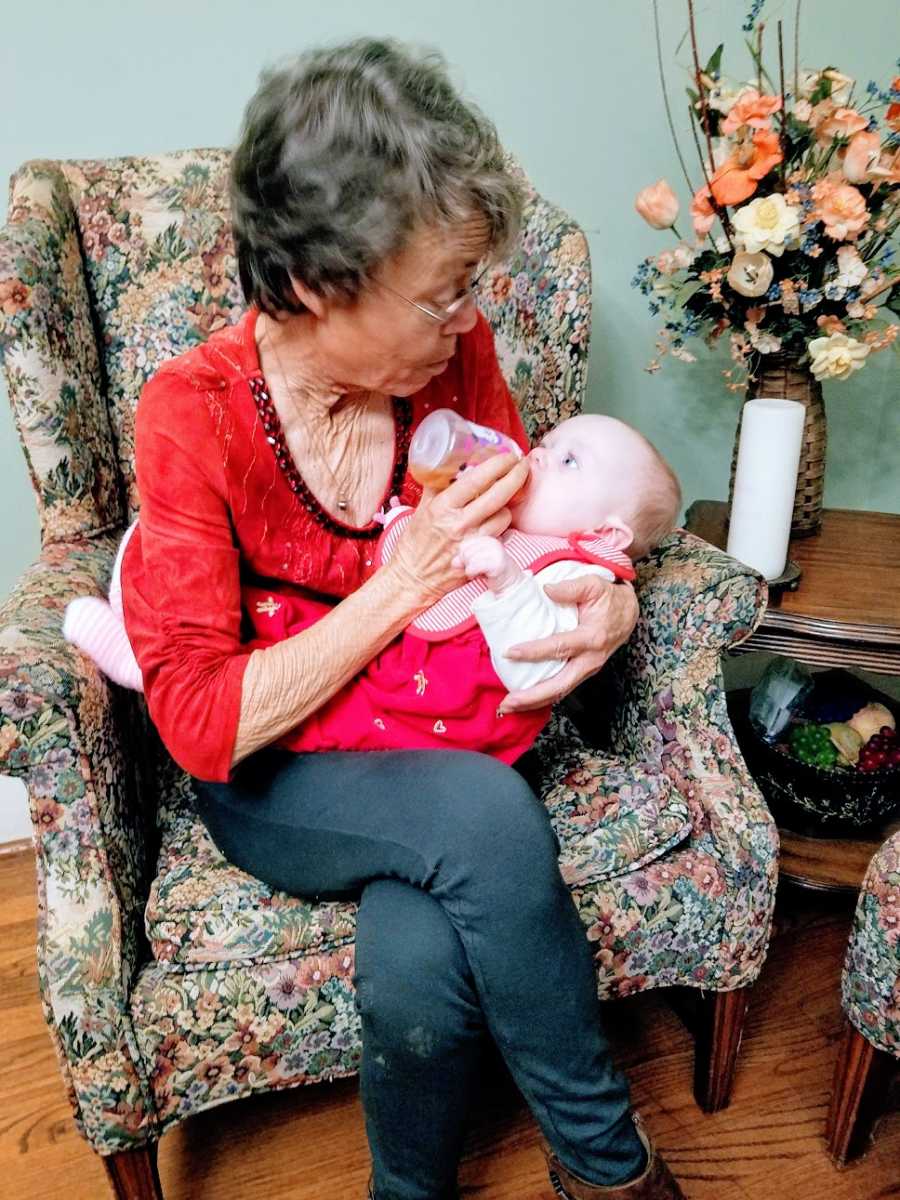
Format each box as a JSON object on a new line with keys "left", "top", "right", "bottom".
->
{"left": 0, "top": 162, "right": 125, "bottom": 546}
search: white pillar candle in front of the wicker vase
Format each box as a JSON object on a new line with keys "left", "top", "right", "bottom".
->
{"left": 728, "top": 397, "right": 806, "bottom": 580}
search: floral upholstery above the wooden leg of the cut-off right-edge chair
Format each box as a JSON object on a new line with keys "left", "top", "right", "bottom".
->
{"left": 841, "top": 833, "right": 900, "bottom": 1058}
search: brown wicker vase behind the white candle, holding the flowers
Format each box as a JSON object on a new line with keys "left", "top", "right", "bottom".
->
{"left": 728, "top": 354, "right": 828, "bottom": 538}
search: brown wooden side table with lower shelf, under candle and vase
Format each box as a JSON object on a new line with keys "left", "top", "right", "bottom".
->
{"left": 685, "top": 500, "right": 900, "bottom": 892}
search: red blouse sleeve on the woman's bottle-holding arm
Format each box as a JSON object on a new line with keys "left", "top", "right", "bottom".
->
{"left": 122, "top": 370, "right": 250, "bottom": 781}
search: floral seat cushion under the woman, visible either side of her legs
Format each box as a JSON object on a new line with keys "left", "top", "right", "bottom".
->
{"left": 145, "top": 718, "right": 690, "bottom": 967}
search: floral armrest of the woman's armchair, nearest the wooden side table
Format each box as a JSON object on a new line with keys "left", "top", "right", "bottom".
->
{"left": 580, "top": 530, "right": 776, "bottom": 874}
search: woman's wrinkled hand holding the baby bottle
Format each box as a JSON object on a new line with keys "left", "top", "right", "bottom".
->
{"left": 388, "top": 454, "right": 528, "bottom": 606}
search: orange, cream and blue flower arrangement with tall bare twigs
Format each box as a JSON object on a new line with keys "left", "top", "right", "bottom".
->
{"left": 632, "top": 0, "right": 900, "bottom": 391}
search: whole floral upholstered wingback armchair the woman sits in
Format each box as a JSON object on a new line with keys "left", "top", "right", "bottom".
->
{"left": 0, "top": 150, "right": 776, "bottom": 1198}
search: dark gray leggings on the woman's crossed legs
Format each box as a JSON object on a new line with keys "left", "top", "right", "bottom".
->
{"left": 196, "top": 750, "right": 643, "bottom": 1200}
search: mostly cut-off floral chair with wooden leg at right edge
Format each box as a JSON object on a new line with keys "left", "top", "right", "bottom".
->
{"left": 827, "top": 833, "right": 900, "bottom": 1166}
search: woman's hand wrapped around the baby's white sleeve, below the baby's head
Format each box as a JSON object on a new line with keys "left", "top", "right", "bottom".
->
{"left": 500, "top": 575, "right": 638, "bottom": 713}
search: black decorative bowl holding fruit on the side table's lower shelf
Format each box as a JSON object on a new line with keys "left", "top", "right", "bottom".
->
{"left": 728, "top": 672, "right": 900, "bottom": 836}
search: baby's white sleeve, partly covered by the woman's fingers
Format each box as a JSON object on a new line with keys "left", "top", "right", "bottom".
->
{"left": 472, "top": 559, "right": 616, "bottom": 691}
